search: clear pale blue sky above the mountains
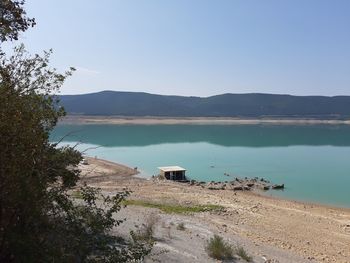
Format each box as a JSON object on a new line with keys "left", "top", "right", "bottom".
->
{"left": 17, "top": 0, "right": 350, "bottom": 96}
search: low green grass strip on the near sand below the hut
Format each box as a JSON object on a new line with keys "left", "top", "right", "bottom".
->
{"left": 123, "top": 200, "right": 223, "bottom": 214}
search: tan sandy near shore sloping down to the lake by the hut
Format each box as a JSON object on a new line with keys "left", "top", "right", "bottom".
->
{"left": 81, "top": 158, "right": 350, "bottom": 263}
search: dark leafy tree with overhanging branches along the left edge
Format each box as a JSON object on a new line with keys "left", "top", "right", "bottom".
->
{"left": 0, "top": 0, "right": 153, "bottom": 262}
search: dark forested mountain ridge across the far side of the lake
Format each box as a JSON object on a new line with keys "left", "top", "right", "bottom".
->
{"left": 60, "top": 91, "right": 350, "bottom": 119}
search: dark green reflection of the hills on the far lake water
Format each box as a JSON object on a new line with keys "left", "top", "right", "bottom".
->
{"left": 51, "top": 125, "right": 350, "bottom": 147}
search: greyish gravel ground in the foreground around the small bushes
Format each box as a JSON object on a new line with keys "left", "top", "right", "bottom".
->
{"left": 115, "top": 206, "right": 316, "bottom": 263}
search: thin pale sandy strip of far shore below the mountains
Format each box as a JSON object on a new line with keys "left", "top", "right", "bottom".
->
{"left": 60, "top": 115, "right": 350, "bottom": 125}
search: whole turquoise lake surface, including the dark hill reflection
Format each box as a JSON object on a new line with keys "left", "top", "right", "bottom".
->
{"left": 51, "top": 125, "right": 350, "bottom": 207}
